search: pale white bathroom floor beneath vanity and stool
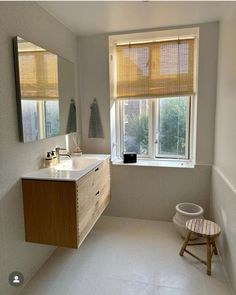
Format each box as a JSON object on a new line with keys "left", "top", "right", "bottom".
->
{"left": 21, "top": 216, "right": 232, "bottom": 295}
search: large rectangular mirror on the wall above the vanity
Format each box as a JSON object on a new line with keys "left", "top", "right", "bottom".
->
{"left": 13, "top": 37, "right": 76, "bottom": 142}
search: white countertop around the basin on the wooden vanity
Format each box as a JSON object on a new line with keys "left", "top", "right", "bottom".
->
{"left": 22, "top": 154, "right": 110, "bottom": 181}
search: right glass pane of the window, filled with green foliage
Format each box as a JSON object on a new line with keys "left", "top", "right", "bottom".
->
{"left": 158, "top": 97, "right": 188, "bottom": 157}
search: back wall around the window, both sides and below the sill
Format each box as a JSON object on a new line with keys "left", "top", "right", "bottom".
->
{"left": 79, "top": 22, "right": 218, "bottom": 220}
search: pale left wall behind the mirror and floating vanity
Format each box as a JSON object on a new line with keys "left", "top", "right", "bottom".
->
{"left": 0, "top": 2, "right": 78, "bottom": 295}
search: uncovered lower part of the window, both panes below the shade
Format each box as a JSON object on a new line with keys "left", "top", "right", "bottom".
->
{"left": 117, "top": 96, "right": 191, "bottom": 159}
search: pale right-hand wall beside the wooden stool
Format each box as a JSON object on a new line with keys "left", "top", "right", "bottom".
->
{"left": 211, "top": 11, "right": 236, "bottom": 291}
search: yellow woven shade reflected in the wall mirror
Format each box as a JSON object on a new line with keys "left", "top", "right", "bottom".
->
{"left": 18, "top": 51, "right": 59, "bottom": 99}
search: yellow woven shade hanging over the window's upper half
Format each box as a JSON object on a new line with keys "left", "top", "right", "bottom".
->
{"left": 116, "top": 39, "right": 194, "bottom": 99}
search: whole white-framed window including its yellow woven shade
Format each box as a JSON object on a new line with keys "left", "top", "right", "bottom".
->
{"left": 110, "top": 29, "right": 198, "bottom": 161}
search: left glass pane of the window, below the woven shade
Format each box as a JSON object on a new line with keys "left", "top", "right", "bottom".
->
{"left": 122, "top": 99, "right": 148, "bottom": 155}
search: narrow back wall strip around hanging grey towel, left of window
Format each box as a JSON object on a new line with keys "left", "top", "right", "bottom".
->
{"left": 79, "top": 35, "right": 110, "bottom": 153}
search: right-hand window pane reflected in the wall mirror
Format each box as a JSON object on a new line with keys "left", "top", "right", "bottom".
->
{"left": 45, "top": 99, "right": 60, "bottom": 138}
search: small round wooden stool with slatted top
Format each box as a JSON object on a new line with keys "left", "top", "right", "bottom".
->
{"left": 179, "top": 219, "right": 221, "bottom": 275}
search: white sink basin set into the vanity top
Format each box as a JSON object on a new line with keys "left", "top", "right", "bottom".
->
{"left": 55, "top": 156, "right": 101, "bottom": 171}
